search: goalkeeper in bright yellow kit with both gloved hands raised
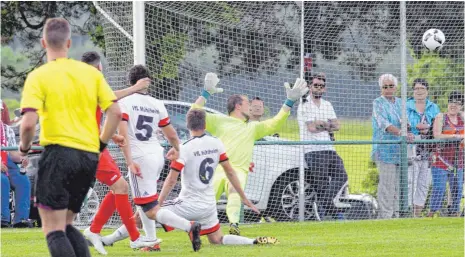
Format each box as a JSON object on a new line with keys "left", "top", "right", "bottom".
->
{"left": 169, "top": 73, "right": 308, "bottom": 235}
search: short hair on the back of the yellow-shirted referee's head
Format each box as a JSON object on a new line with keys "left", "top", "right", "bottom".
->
{"left": 44, "top": 18, "right": 71, "bottom": 49}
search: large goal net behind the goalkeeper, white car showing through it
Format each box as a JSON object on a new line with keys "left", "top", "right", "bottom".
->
{"left": 85, "top": 1, "right": 464, "bottom": 226}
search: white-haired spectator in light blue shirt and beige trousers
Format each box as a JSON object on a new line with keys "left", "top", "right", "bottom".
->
{"left": 372, "top": 74, "right": 413, "bottom": 219}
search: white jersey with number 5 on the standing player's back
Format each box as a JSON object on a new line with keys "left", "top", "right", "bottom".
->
{"left": 118, "top": 93, "right": 170, "bottom": 157}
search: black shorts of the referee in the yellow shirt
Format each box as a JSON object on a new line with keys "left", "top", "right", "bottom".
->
{"left": 36, "top": 145, "right": 99, "bottom": 213}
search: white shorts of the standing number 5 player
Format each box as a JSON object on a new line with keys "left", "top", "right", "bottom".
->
{"left": 128, "top": 152, "right": 165, "bottom": 205}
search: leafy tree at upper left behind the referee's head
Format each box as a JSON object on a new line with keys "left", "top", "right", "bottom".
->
{"left": 1, "top": 1, "right": 97, "bottom": 91}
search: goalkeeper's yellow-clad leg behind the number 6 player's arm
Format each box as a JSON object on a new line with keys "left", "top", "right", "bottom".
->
{"left": 225, "top": 169, "right": 248, "bottom": 235}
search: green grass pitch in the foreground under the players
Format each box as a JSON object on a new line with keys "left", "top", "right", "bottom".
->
{"left": 1, "top": 218, "right": 464, "bottom": 257}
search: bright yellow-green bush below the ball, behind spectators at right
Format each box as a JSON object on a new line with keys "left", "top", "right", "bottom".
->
{"left": 407, "top": 50, "right": 464, "bottom": 110}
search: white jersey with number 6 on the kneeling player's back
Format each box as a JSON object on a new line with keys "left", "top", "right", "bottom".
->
{"left": 171, "top": 134, "right": 228, "bottom": 208}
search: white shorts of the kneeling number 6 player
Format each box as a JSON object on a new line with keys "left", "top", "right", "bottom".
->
{"left": 161, "top": 198, "right": 220, "bottom": 236}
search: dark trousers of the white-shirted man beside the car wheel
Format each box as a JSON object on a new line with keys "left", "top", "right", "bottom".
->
{"left": 305, "top": 150, "right": 348, "bottom": 215}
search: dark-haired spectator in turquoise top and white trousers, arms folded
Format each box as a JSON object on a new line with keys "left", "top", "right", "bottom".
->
{"left": 407, "top": 78, "right": 440, "bottom": 217}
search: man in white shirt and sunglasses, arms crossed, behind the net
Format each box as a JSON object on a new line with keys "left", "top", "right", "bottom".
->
{"left": 297, "top": 73, "right": 348, "bottom": 218}
